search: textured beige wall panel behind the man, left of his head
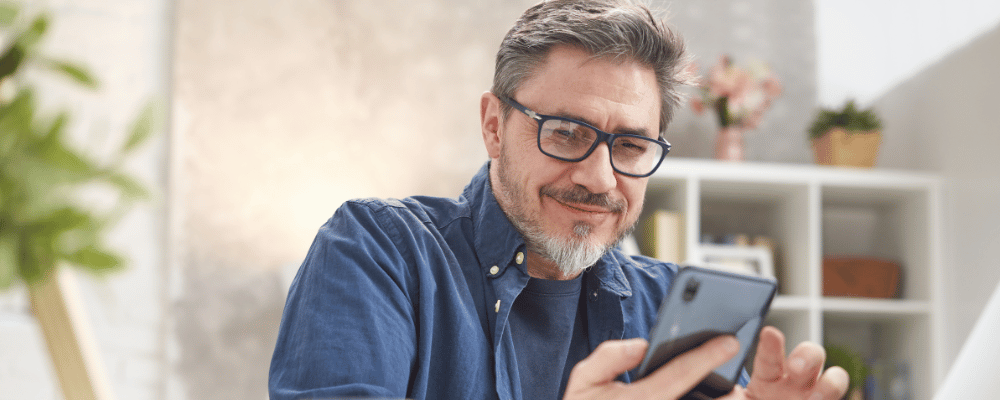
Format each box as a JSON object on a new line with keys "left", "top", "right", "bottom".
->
{"left": 172, "top": 0, "right": 529, "bottom": 398}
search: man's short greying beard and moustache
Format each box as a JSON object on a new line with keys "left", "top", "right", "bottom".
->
{"left": 495, "top": 148, "right": 635, "bottom": 276}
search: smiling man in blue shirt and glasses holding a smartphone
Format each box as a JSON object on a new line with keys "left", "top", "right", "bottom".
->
{"left": 270, "top": 0, "right": 847, "bottom": 400}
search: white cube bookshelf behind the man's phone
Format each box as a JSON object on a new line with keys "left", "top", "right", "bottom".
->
{"left": 645, "top": 158, "right": 944, "bottom": 399}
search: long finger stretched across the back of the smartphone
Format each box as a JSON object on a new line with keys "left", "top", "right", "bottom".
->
{"left": 633, "top": 336, "right": 740, "bottom": 398}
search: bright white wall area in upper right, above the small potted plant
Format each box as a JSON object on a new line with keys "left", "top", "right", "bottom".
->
{"left": 815, "top": 0, "right": 1000, "bottom": 107}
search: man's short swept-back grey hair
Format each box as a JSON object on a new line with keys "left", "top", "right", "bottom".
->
{"left": 492, "top": 0, "right": 691, "bottom": 134}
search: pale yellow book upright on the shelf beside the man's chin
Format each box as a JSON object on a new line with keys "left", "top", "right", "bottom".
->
{"left": 639, "top": 210, "right": 684, "bottom": 264}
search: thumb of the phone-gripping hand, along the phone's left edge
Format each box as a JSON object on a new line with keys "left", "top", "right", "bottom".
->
{"left": 566, "top": 338, "right": 648, "bottom": 393}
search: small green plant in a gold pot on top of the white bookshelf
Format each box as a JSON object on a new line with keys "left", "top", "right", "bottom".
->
{"left": 809, "top": 100, "right": 882, "bottom": 168}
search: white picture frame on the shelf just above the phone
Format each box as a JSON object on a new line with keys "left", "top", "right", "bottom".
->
{"left": 694, "top": 244, "right": 775, "bottom": 279}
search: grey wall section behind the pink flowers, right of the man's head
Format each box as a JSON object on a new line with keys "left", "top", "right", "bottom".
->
{"left": 655, "top": 0, "right": 816, "bottom": 163}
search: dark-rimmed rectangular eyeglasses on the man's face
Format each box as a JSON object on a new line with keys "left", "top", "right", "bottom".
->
{"left": 500, "top": 97, "right": 670, "bottom": 178}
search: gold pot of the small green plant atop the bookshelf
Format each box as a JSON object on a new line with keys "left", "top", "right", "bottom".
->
{"left": 812, "top": 128, "right": 882, "bottom": 168}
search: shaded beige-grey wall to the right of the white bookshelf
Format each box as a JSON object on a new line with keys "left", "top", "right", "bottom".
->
{"left": 874, "top": 22, "right": 1000, "bottom": 378}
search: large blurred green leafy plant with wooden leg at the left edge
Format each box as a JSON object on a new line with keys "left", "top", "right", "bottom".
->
{"left": 0, "top": 2, "right": 156, "bottom": 399}
